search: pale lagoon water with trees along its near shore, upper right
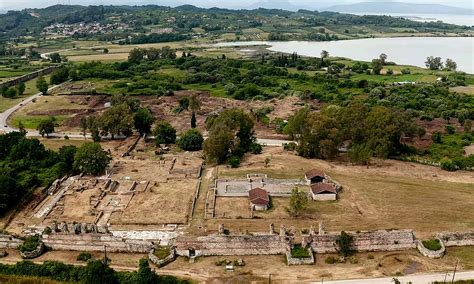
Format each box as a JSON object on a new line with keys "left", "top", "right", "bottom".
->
{"left": 215, "top": 37, "right": 474, "bottom": 74}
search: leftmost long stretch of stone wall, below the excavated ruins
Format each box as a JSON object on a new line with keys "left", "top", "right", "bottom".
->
{"left": 43, "top": 234, "right": 153, "bottom": 253}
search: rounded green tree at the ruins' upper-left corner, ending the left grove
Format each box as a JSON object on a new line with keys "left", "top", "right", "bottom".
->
{"left": 73, "top": 142, "right": 112, "bottom": 175}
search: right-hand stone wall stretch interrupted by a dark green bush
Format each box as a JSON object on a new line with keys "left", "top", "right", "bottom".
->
{"left": 307, "top": 230, "right": 415, "bottom": 253}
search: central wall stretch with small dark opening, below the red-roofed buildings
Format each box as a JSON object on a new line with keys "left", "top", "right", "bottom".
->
{"left": 175, "top": 234, "right": 288, "bottom": 257}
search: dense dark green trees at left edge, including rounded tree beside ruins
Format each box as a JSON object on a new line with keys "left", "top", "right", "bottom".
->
{"left": 0, "top": 132, "right": 110, "bottom": 214}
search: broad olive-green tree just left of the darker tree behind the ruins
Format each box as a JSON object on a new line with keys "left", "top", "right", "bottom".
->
{"left": 100, "top": 103, "right": 133, "bottom": 140}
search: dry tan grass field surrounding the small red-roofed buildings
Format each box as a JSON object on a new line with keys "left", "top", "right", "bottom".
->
{"left": 210, "top": 148, "right": 474, "bottom": 236}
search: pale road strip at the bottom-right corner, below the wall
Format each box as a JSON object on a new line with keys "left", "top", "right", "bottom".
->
{"left": 322, "top": 271, "right": 474, "bottom": 284}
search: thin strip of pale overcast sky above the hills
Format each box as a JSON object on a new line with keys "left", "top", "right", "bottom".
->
{"left": 0, "top": 0, "right": 473, "bottom": 10}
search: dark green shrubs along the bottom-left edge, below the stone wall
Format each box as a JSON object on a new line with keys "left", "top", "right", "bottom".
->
{"left": 0, "top": 259, "right": 189, "bottom": 284}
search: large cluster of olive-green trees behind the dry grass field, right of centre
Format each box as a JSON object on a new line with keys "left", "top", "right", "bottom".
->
{"left": 285, "top": 102, "right": 423, "bottom": 164}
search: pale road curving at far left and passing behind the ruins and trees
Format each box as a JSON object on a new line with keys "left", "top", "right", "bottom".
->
{"left": 0, "top": 89, "right": 290, "bottom": 146}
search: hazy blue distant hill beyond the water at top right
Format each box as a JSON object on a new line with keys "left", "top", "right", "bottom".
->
{"left": 323, "top": 2, "right": 474, "bottom": 15}
